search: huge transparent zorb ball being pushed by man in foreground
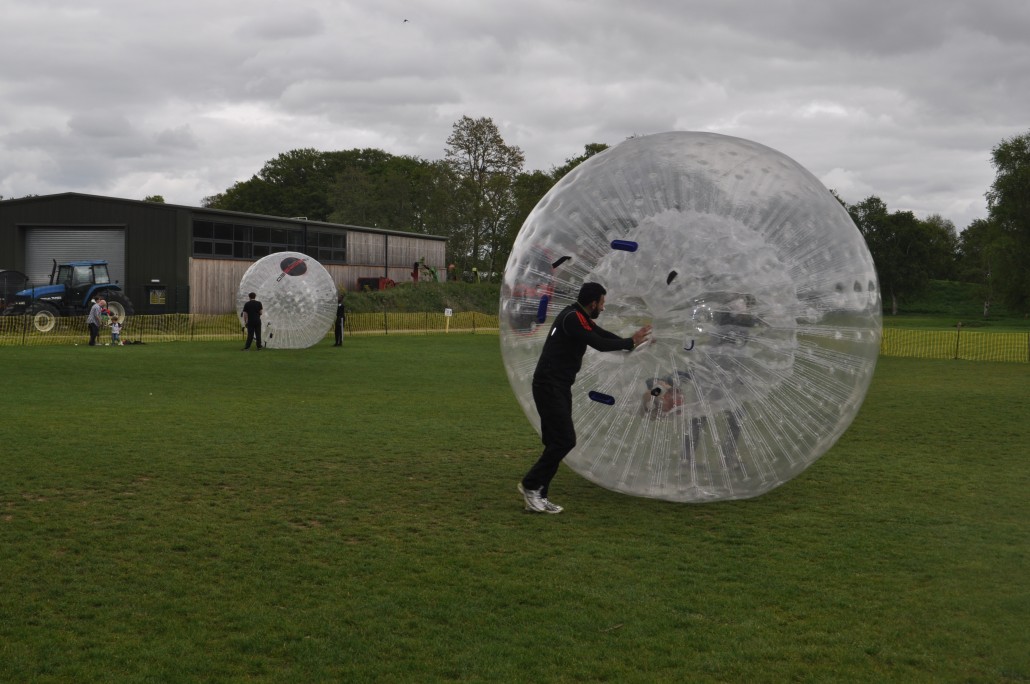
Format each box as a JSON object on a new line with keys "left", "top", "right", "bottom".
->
{"left": 500, "top": 133, "right": 881, "bottom": 502}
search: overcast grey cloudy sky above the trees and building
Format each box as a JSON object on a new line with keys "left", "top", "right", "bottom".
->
{"left": 0, "top": 0, "right": 1030, "bottom": 231}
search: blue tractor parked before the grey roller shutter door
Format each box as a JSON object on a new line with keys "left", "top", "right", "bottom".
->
{"left": 3, "top": 260, "right": 134, "bottom": 333}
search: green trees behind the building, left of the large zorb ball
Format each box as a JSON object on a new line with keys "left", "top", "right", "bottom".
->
{"left": 203, "top": 116, "right": 608, "bottom": 279}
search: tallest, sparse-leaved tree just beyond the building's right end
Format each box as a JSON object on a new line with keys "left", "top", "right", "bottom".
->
{"left": 444, "top": 116, "right": 525, "bottom": 277}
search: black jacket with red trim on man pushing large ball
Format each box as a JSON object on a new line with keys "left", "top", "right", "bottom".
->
{"left": 533, "top": 303, "right": 633, "bottom": 385}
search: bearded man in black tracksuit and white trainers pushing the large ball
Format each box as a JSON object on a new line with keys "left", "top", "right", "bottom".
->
{"left": 518, "top": 282, "right": 651, "bottom": 513}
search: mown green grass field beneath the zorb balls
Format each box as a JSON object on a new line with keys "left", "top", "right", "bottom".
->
{"left": 0, "top": 336, "right": 1030, "bottom": 682}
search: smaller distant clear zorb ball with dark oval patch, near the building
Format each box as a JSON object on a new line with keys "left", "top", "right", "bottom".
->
{"left": 236, "top": 251, "right": 337, "bottom": 349}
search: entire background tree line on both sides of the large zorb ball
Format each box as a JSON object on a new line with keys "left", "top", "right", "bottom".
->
{"left": 203, "top": 116, "right": 1030, "bottom": 315}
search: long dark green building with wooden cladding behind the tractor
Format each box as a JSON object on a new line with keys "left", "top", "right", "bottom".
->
{"left": 0, "top": 193, "right": 447, "bottom": 313}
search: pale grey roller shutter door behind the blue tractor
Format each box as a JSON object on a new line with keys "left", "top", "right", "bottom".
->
{"left": 25, "top": 228, "right": 126, "bottom": 287}
